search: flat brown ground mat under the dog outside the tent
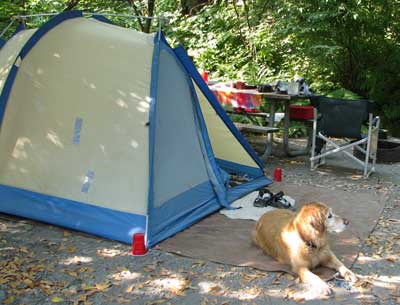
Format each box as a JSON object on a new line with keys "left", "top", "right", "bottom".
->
{"left": 156, "top": 184, "right": 384, "bottom": 279}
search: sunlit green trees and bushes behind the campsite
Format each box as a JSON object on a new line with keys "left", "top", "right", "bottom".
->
{"left": 0, "top": 0, "right": 400, "bottom": 133}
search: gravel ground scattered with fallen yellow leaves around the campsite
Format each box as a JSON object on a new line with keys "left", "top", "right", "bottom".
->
{"left": 0, "top": 145, "right": 400, "bottom": 305}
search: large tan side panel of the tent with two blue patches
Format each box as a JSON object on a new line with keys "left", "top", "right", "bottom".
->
{"left": 0, "top": 18, "right": 154, "bottom": 215}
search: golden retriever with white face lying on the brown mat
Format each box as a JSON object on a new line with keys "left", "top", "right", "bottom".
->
{"left": 252, "top": 202, "right": 357, "bottom": 295}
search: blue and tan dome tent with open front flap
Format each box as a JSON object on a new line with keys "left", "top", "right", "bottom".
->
{"left": 0, "top": 11, "right": 271, "bottom": 247}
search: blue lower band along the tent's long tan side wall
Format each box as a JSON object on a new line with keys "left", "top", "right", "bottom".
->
{"left": 0, "top": 185, "right": 146, "bottom": 243}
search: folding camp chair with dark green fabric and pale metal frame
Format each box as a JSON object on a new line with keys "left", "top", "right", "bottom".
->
{"left": 310, "top": 96, "right": 380, "bottom": 178}
